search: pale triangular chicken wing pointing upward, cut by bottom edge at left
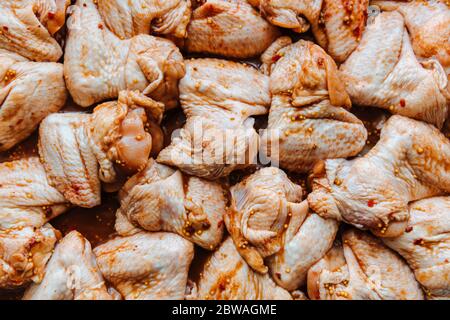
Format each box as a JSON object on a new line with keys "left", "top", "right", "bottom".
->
{"left": 23, "top": 231, "right": 113, "bottom": 300}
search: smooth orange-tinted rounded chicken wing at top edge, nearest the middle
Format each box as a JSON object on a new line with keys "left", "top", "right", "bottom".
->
{"left": 184, "top": 0, "right": 279, "bottom": 59}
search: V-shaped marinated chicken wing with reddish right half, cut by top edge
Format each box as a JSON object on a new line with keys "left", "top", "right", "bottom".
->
{"left": 251, "top": 0, "right": 369, "bottom": 63}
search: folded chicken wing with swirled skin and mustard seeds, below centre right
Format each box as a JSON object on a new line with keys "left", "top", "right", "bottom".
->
{"left": 225, "top": 168, "right": 338, "bottom": 291}
